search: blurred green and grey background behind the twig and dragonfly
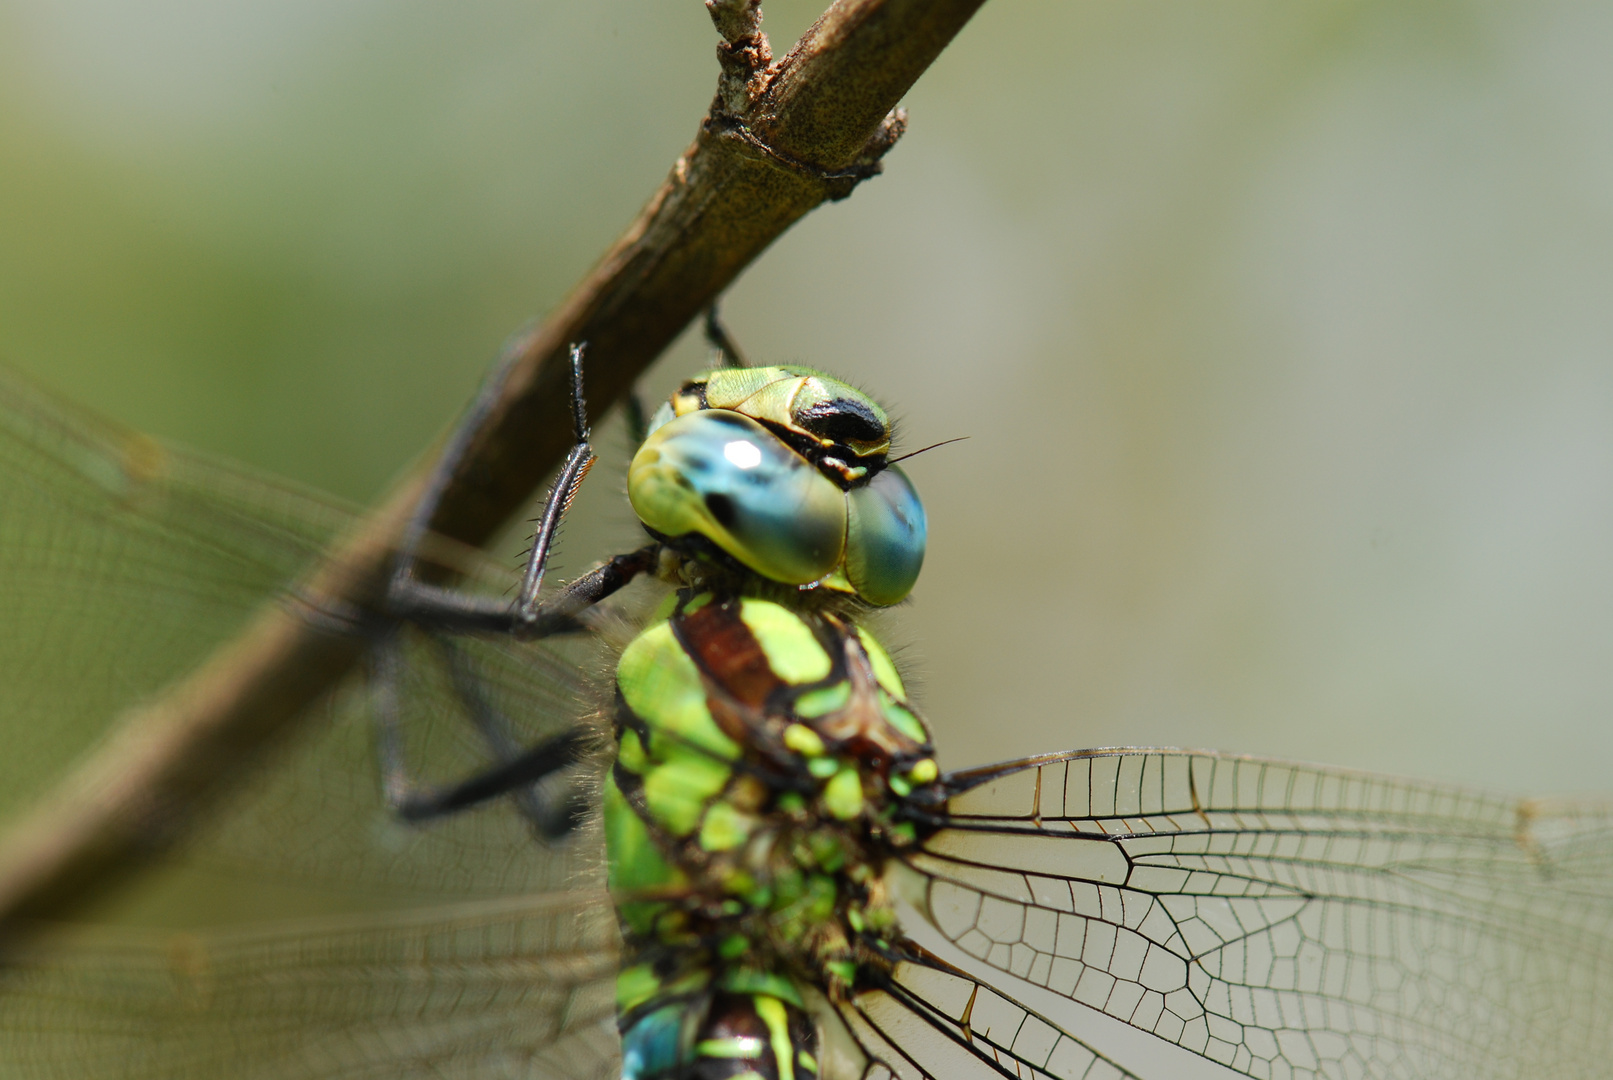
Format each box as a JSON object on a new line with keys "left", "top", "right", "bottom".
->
{"left": 0, "top": 0, "right": 1613, "bottom": 802}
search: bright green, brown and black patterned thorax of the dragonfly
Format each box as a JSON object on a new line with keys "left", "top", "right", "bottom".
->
{"left": 605, "top": 592, "right": 937, "bottom": 1077}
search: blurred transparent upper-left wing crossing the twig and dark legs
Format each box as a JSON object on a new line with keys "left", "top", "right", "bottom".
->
{"left": 0, "top": 371, "right": 608, "bottom": 914}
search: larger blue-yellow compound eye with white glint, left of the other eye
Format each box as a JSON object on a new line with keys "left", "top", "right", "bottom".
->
{"left": 627, "top": 409, "right": 847, "bottom": 585}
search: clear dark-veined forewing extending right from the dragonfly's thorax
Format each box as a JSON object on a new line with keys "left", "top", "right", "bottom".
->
{"left": 905, "top": 751, "right": 1613, "bottom": 1080}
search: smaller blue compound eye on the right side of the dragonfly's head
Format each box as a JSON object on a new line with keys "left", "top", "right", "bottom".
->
{"left": 845, "top": 466, "right": 927, "bottom": 606}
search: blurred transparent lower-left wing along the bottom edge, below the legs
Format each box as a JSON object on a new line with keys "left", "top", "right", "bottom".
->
{"left": 0, "top": 893, "right": 621, "bottom": 1080}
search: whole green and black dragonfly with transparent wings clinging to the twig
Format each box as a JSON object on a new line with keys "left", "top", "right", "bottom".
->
{"left": 0, "top": 330, "right": 1613, "bottom": 1080}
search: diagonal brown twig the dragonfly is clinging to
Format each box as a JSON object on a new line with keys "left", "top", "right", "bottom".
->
{"left": 0, "top": 0, "right": 984, "bottom": 927}
